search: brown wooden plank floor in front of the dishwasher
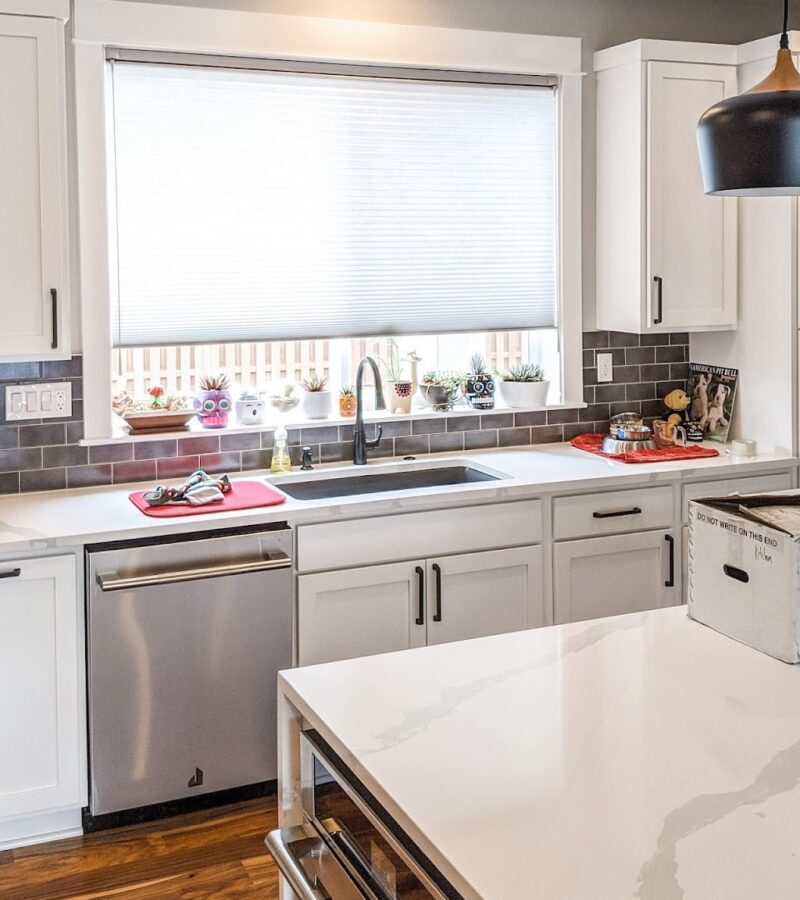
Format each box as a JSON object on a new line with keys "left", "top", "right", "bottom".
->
{"left": 0, "top": 797, "right": 278, "bottom": 900}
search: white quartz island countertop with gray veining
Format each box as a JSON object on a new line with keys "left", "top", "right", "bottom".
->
{"left": 281, "top": 608, "right": 800, "bottom": 900}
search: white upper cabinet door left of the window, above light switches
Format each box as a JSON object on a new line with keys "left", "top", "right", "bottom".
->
{"left": 0, "top": 11, "right": 70, "bottom": 360}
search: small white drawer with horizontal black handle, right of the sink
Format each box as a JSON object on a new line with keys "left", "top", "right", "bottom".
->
{"left": 553, "top": 487, "right": 672, "bottom": 540}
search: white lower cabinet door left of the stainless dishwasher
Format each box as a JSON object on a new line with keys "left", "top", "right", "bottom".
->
{"left": 0, "top": 555, "right": 81, "bottom": 819}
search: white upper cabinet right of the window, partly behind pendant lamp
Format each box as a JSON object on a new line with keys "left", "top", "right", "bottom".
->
{"left": 595, "top": 41, "right": 737, "bottom": 334}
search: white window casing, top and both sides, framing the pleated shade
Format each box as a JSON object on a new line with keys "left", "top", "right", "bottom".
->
{"left": 74, "top": 0, "right": 584, "bottom": 440}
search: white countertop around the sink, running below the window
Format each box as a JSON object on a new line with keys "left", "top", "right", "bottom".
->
{"left": 0, "top": 444, "right": 798, "bottom": 552}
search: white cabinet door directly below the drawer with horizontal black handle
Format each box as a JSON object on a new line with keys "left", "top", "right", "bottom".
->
{"left": 553, "top": 531, "right": 682, "bottom": 624}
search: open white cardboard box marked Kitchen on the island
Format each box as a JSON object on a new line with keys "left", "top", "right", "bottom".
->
{"left": 688, "top": 493, "right": 800, "bottom": 663}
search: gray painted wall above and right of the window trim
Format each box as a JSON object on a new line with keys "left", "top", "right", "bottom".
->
{"left": 120, "top": 0, "right": 782, "bottom": 329}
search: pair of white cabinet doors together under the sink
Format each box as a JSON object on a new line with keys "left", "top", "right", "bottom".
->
{"left": 297, "top": 546, "right": 545, "bottom": 666}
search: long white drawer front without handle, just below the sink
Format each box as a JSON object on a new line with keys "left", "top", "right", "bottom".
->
{"left": 297, "top": 500, "right": 542, "bottom": 572}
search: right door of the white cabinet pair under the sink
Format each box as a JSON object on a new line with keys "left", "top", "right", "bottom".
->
{"left": 427, "top": 547, "right": 545, "bottom": 644}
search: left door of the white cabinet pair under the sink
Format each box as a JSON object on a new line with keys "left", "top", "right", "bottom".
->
{"left": 297, "top": 560, "right": 425, "bottom": 666}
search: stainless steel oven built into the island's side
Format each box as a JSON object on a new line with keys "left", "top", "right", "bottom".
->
{"left": 267, "top": 731, "right": 460, "bottom": 900}
